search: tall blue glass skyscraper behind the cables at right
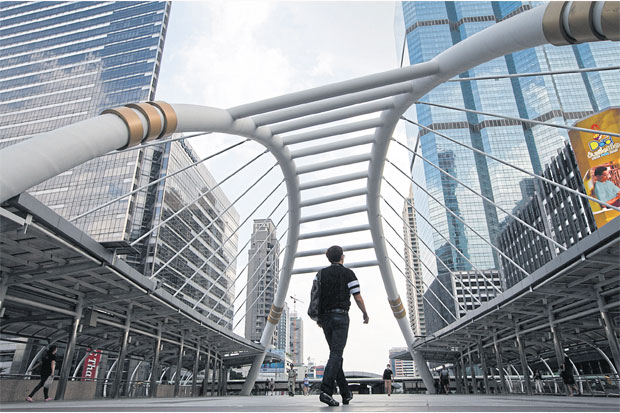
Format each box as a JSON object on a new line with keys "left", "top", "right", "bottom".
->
{"left": 395, "top": 1, "right": 620, "bottom": 332}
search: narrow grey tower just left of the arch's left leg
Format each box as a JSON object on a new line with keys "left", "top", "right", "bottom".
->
{"left": 245, "top": 219, "right": 280, "bottom": 347}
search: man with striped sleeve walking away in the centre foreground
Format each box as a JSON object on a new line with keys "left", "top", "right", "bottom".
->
{"left": 317, "top": 245, "right": 368, "bottom": 406}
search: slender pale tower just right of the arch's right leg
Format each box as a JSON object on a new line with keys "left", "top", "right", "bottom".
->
{"left": 403, "top": 187, "right": 426, "bottom": 336}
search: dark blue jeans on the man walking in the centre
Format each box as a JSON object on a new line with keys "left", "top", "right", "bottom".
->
{"left": 320, "top": 313, "right": 351, "bottom": 398}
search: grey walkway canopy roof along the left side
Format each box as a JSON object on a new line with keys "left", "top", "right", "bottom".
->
{"left": 0, "top": 193, "right": 278, "bottom": 370}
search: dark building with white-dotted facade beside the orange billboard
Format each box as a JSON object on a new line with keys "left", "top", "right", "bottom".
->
{"left": 497, "top": 144, "right": 596, "bottom": 289}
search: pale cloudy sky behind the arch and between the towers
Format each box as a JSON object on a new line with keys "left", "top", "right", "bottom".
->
{"left": 156, "top": 1, "right": 418, "bottom": 373}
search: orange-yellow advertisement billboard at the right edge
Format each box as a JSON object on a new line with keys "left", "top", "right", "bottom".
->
{"left": 568, "top": 107, "right": 620, "bottom": 228}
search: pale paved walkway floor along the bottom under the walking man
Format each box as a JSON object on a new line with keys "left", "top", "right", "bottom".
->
{"left": 0, "top": 394, "right": 620, "bottom": 412}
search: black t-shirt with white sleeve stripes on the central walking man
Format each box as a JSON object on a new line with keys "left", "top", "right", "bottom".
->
{"left": 319, "top": 264, "right": 360, "bottom": 314}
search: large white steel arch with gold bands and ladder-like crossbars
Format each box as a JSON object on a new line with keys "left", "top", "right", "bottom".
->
{"left": 0, "top": 2, "right": 620, "bottom": 395}
